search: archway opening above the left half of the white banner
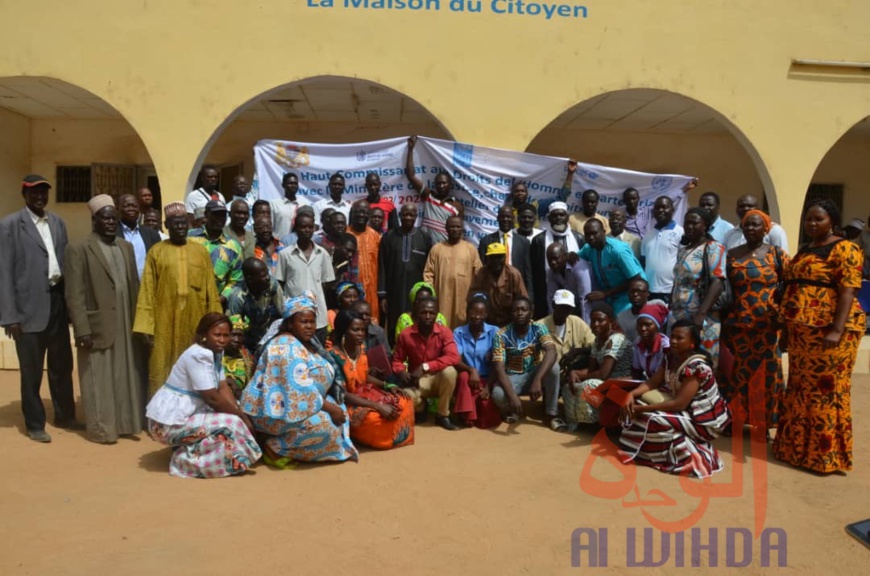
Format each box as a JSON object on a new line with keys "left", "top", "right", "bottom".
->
{"left": 190, "top": 76, "right": 452, "bottom": 195}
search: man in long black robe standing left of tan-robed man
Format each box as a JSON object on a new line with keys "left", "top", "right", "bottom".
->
{"left": 378, "top": 202, "right": 432, "bottom": 338}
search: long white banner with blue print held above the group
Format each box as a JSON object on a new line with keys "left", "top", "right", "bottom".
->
{"left": 253, "top": 137, "right": 692, "bottom": 242}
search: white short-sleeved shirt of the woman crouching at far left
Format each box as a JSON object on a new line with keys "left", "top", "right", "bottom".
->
{"left": 145, "top": 344, "right": 224, "bottom": 425}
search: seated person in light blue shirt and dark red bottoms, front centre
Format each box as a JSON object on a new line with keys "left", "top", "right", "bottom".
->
{"left": 453, "top": 292, "right": 501, "bottom": 428}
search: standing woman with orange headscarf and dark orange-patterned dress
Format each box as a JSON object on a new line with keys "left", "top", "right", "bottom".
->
{"left": 721, "top": 210, "right": 789, "bottom": 432}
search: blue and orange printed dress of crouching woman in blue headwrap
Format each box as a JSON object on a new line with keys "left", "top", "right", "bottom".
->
{"left": 241, "top": 334, "right": 358, "bottom": 462}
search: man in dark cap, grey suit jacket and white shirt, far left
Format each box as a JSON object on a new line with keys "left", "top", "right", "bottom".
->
{"left": 0, "top": 174, "right": 82, "bottom": 442}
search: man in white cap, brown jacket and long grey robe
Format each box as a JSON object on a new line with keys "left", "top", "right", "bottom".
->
{"left": 63, "top": 194, "right": 145, "bottom": 444}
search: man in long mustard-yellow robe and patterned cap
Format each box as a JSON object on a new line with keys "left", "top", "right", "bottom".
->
{"left": 133, "top": 202, "right": 223, "bottom": 397}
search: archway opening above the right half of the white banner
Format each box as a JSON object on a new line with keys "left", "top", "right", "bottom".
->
{"left": 527, "top": 88, "right": 777, "bottom": 223}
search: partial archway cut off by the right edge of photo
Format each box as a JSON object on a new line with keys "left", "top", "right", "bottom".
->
{"left": 801, "top": 116, "right": 870, "bottom": 244}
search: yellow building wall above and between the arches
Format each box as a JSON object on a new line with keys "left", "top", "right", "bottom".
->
{"left": 0, "top": 0, "right": 870, "bottom": 245}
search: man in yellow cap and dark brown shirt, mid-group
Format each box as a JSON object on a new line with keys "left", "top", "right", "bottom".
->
{"left": 468, "top": 242, "right": 529, "bottom": 327}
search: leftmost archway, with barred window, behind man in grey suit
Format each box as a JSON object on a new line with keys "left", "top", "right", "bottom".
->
{"left": 0, "top": 76, "right": 160, "bottom": 240}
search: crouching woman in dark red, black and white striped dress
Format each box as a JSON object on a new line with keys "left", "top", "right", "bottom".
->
{"left": 619, "top": 320, "right": 731, "bottom": 478}
